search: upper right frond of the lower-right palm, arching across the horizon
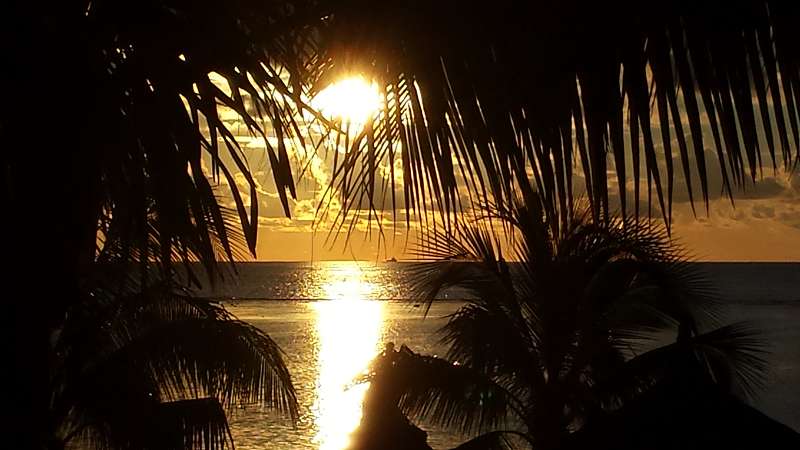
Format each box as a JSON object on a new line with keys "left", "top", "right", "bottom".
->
{"left": 556, "top": 216, "right": 720, "bottom": 329}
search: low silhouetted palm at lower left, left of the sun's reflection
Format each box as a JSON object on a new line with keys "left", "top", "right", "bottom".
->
{"left": 51, "top": 280, "right": 297, "bottom": 449}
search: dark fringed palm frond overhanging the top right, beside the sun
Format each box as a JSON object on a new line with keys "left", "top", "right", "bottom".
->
{"left": 317, "top": 0, "right": 800, "bottom": 229}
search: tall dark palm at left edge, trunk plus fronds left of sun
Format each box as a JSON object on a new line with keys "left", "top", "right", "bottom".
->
{"left": 0, "top": 0, "right": 318, "bottom": 442}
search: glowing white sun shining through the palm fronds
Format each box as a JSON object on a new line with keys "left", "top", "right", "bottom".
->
{"left": 311, "top": 76, "right": 383, "bottom": 128}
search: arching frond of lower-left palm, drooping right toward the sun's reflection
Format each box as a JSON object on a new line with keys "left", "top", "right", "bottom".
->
{"left": 96, "top": 312, "right": 297, "bottom": 420}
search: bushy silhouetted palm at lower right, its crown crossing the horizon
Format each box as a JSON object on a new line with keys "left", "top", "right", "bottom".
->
{"left": 356, "top": 198, "right": 766, "bottom": 450}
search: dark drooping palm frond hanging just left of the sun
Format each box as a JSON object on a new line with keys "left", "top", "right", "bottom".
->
{"left": 85, "top": 2, "right": 312, "bottom": 274}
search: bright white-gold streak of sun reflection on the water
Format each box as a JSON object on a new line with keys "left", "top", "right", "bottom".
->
{"left": 311, "top": 263, "right": 384, "bottom": 450}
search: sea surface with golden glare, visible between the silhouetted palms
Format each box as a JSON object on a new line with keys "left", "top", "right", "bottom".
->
{"left": 201, "top": 261, "right": 800, "bottom": 450}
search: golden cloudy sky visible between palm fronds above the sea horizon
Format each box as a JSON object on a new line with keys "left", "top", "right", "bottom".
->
{"left": 206, "top": 75, "right": 800, "bottom": 261}
